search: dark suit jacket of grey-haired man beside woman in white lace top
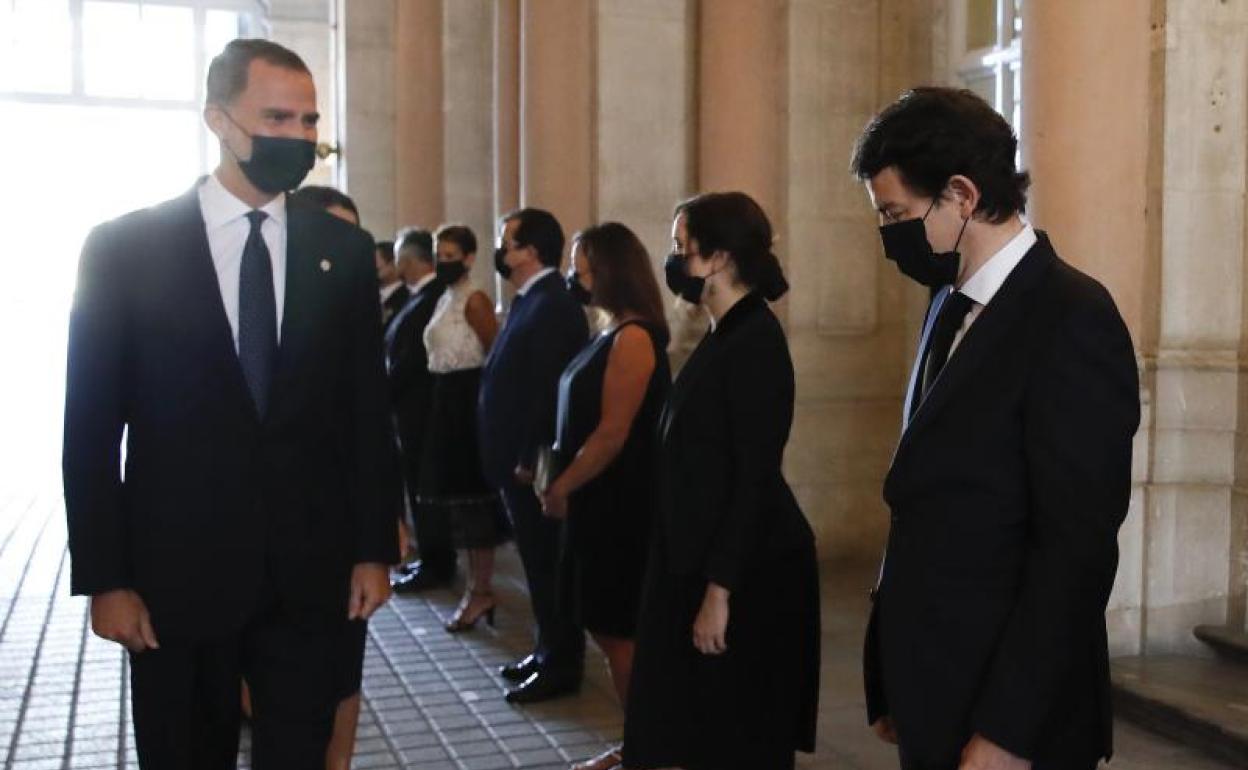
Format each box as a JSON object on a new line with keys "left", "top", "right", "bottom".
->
{"left": 386, "top": 278, "right": 447, "bottom": 449}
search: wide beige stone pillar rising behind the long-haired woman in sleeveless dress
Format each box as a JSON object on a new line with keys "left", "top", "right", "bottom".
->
{"left": 595, "top": 0, "right": 696, "bottom": 316}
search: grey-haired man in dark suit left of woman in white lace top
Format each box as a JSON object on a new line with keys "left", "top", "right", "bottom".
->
{"left": 386, "top": 227, "right": 456, "bottom": 593}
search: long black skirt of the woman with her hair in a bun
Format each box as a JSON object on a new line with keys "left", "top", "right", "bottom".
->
{"left": 624, "top": 534, "right": 820, "bottom": 770}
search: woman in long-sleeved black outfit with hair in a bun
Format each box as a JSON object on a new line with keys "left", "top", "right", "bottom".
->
{"left": 624, "top": 192, "right": 819, "bottom": 770}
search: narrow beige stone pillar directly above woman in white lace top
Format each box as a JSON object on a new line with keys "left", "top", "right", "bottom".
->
{"left": 442, "top": 0, "right": 494, "bottom": 287}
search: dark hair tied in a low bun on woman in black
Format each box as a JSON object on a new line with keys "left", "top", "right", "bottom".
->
{"left": 673, "top": 192, "right": 789, "bottom": 302}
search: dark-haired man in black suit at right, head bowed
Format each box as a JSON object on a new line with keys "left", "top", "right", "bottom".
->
{"left": 852, "top": 89, "right": 1139, "bottom": 770}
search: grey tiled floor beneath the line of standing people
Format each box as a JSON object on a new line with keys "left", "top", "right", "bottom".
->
{"left": 0, "top": 483, "right": 1228, "bottom": 770}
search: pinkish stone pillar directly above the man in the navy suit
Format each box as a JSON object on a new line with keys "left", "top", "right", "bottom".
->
{"left": 519, "top": 0, "right": 595, "bottom": 265}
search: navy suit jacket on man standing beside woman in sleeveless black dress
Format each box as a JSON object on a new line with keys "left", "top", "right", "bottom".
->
{"left": 477, "top": 272, "right": 589, "bottom": 488}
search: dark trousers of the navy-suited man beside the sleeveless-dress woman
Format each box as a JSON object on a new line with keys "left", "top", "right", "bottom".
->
{"left": 500, "top": 483, "right": 585, "bottom": 676}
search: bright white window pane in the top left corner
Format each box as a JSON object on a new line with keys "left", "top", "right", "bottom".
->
{"left": 0, "top": 0, "right": 74, "bottom": 94}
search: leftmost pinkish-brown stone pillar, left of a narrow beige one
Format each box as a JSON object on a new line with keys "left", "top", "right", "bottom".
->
{"left": 396, "top": 0, "right": 446, "bottom": 230}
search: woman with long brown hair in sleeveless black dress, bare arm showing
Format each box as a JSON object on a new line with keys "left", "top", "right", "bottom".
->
{"left": 542, "top": 222, "right": 671, "bottom": 770}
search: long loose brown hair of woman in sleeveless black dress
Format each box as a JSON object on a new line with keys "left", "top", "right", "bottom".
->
{"left": 572, "top": 222, "right": 668, "bottom": 343}
